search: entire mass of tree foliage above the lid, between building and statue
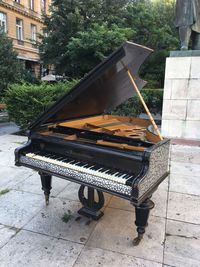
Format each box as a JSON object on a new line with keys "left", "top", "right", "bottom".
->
{"left": 41, "top": 0, "right": 178, "bottom": 88}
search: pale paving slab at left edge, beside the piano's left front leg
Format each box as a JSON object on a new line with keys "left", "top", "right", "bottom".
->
{"left": 0, "top": 190, "right": 44, "bottom": 228}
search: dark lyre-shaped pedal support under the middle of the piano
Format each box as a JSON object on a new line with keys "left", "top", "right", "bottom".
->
{"left": 78, "top": 185, "right": 104, "bottom": 220}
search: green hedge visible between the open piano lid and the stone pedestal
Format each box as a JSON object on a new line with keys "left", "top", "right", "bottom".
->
{"left": 111, "top": 89, "right": 163, "bottom": 117}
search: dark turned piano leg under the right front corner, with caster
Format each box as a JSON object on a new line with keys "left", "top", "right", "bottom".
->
{"left": 133, "top": 198, "right": 154, "bottom": 246}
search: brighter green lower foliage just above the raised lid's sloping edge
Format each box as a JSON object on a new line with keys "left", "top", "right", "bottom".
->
{"left": 67, "top": 24, "right": 133, "bottom": 77}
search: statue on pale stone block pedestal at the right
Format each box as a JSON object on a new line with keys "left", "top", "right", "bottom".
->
{"left": 162, "top": 0, "right": 200, "bottom": 140}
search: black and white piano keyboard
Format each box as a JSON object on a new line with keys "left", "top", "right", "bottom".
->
{"left": 26, "top": 153, "right": 134, "bottom": 184}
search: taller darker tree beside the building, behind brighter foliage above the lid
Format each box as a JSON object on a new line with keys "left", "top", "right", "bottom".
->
{"left": 40, "top": 0, "right": 128, "bottom": 74}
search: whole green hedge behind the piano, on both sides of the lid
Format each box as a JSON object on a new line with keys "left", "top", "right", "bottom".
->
{"left": 4, "top": 80, "right": 163, "bottom": 130}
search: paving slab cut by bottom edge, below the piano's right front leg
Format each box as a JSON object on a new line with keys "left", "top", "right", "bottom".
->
{"left": 74, "top": 247, "right": 162, "bottom": 267}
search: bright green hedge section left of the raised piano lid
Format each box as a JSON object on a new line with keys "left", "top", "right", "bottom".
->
{"left": 4, "top": 80, "right": 78, "bottom": 130}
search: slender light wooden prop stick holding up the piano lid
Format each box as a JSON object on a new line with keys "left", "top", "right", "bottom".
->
{"left": 121, "top": 61, "right": 163, "bottom": 140}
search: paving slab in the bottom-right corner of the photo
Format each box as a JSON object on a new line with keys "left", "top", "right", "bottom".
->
{"left": 164, "top": 220, "right": 200, "bottom": 267}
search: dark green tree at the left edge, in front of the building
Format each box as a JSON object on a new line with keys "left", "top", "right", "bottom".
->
{"left": 0, "top": 31, "right": 21, "bottom": 95}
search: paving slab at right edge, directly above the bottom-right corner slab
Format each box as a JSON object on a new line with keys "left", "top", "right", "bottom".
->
{"left": 167, "top": 192, "right": 200, "bottom": 224}
